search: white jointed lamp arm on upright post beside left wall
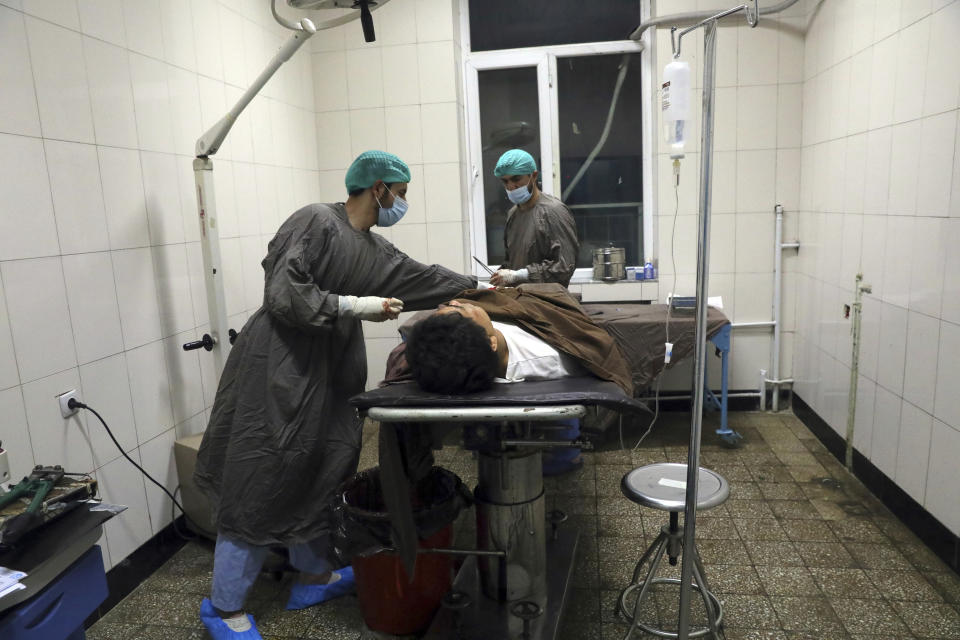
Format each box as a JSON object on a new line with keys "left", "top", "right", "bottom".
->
{"left": 193, "top": 0, "right": 390, "bottom": 378}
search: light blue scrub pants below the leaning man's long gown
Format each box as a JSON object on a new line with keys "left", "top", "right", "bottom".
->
{"left": 210, "top": 534, "right": 333, "bottom": 612}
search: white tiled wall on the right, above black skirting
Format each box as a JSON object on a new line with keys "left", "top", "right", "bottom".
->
{"left": 796, "top": 0, "right": 960, "bottom": 533}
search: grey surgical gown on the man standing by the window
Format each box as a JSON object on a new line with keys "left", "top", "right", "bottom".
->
{"left": 500, "top": 191, "right": 580, "bottom": 286}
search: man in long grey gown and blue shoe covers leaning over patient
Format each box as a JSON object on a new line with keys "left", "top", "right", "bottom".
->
{"left": 194, "top": 151, "right": 476, "bottom": 640}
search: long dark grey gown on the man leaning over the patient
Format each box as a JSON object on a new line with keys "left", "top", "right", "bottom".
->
{"left": 194, "top": 203, "right": 476, "bottom": 545}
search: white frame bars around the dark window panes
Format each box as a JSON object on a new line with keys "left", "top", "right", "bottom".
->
{"left": 460, "top": 0, "right": 656, "bottom": 282}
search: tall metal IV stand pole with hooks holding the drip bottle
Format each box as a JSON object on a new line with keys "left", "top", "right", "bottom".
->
{"left": 670, "top": 0, "right": 760, "bottom": 640}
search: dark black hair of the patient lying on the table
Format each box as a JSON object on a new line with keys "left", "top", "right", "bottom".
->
{"left": 406, "top": 313, "right": 497, "bottom": 394}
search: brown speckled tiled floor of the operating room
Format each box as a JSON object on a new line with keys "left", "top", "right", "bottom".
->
{"left": 88, "top": 413, "right": 960, "bottom": 640}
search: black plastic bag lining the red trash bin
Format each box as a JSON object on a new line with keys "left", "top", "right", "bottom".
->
{"left": 333, "top": 467, "right": 473, "bottom": 563}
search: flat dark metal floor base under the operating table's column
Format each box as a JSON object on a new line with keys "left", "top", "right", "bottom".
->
{"left": 423, "top": 526, "right": 580, "bottom": 640}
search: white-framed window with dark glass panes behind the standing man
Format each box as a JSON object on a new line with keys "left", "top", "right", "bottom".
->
{"left": 464, "top": 0, "right": 653, "bottom": 278}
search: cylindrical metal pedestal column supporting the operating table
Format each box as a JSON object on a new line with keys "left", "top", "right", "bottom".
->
{"left": 474, "top": 451, "right": 547, "bottom": 601}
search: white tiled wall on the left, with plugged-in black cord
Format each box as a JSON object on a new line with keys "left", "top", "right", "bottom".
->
{"left": 0, "top": 0, "right": 322, "bottom": 563}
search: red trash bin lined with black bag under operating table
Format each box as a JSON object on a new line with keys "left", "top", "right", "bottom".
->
{"left": 335, "top": 467, "right": 470, "bottom": 635}
